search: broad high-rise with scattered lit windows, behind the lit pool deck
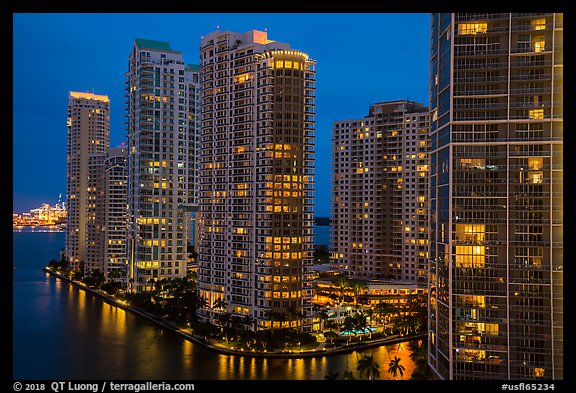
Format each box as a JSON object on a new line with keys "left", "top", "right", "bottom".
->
{"left": 331, "top": 100, "right": 430, "bottom": 286}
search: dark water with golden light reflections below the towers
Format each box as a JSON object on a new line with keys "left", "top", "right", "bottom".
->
{"left": 13, "top": 232, "right": 414, "bottom": 380}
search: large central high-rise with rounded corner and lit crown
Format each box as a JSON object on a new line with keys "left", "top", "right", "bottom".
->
{"left": 198, "top": 30, "right": 315, "bottom": 331}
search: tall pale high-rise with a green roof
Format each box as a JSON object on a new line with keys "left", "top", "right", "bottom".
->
{"left": 126, "top": 38, "right": 197, "bottom": 292}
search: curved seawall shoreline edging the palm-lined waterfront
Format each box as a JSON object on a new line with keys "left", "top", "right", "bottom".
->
{"left": 42, "top": 267, "right": 426, "bottom": 359}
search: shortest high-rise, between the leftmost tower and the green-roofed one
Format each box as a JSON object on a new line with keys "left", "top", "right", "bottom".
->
{"left": 84, "top": 147, "right": 128, "bottom": 281}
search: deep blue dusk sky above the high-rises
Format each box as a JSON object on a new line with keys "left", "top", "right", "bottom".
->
{"left": 13, "top": 13, "right": 430, "bottom": 216}
